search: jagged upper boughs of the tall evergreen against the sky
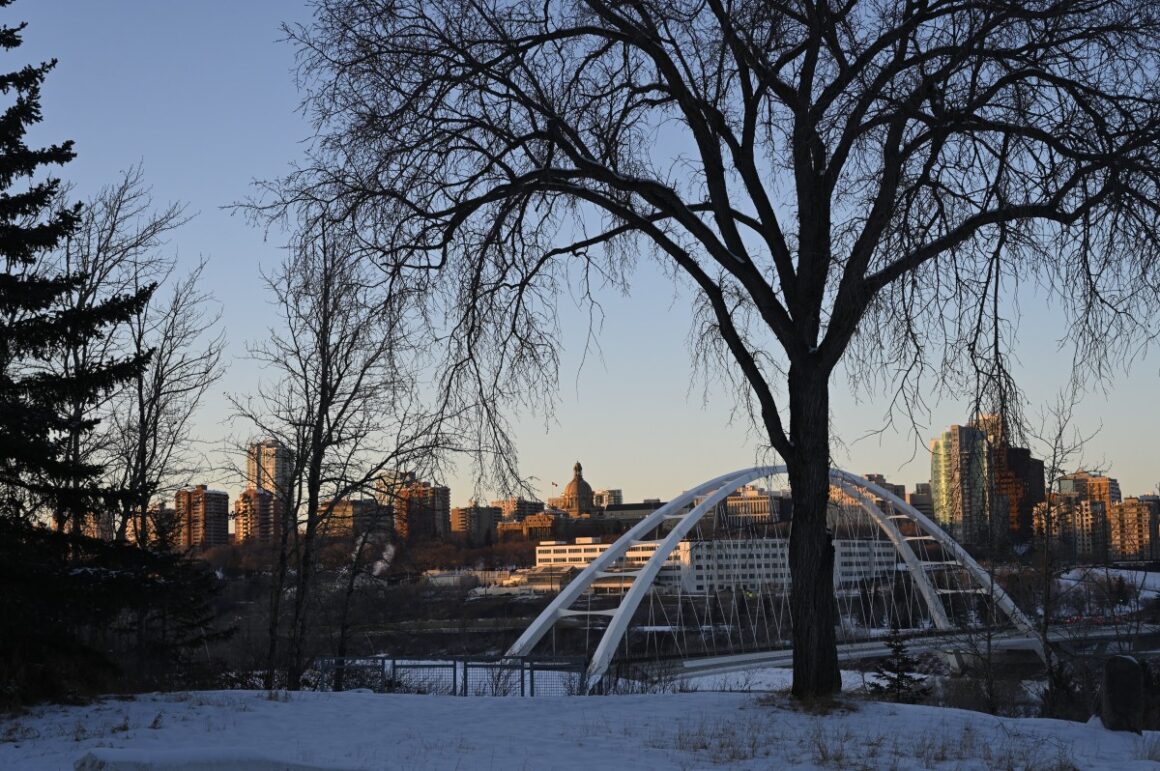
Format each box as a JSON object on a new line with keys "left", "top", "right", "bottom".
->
{"left": 0, "top": 0, "right": 153, "bottom": 532}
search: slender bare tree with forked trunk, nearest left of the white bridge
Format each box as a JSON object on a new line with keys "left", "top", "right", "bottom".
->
{"left": 234, "top": 220, "right": 445, "bottom": 689}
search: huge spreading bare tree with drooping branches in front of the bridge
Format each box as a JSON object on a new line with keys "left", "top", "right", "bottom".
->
{"left": 269, "top": 0, "right": 1160, "bottom": 697}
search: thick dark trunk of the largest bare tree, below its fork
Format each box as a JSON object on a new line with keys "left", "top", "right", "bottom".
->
{"left": 785, "top": 365, "right": 842, "bottom": 699}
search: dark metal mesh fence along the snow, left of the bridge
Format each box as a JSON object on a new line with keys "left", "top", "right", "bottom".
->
{"left": 314, "top": 656, "right": 587, "bottom": 697}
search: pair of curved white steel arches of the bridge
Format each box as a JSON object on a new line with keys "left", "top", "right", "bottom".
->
{"left": 507, "top": 466, "right": 1043, "bottom": 684}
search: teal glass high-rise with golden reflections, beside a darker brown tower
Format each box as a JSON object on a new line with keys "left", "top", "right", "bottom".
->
{"left": 930, "top": 425, "right": 992, "bottom": 546}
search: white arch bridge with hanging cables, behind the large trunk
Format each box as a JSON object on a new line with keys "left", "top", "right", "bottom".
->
{"left": 507, "top": 466, "right": 1043, "bottom": 688}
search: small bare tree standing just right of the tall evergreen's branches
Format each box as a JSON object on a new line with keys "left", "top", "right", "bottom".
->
{"left": 107, "top": 261, "right": 225, "bottom": 548}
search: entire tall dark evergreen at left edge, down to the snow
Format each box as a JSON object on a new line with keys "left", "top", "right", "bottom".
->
{"left": 0, "top": 0, "right": 229, "bottom": 710}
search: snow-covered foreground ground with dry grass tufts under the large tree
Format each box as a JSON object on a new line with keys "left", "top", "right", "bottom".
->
{"left": 0, "top": 672, "right": 1160, "bottom": 771}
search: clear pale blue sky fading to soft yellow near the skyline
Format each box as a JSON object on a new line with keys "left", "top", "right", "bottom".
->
{"left": 18, "top": 0, "right": 1160, "bottom": 504}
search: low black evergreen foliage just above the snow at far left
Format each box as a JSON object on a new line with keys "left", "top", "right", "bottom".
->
{"left": 0, "top": 517, "right": 233, "bottom": 713}
